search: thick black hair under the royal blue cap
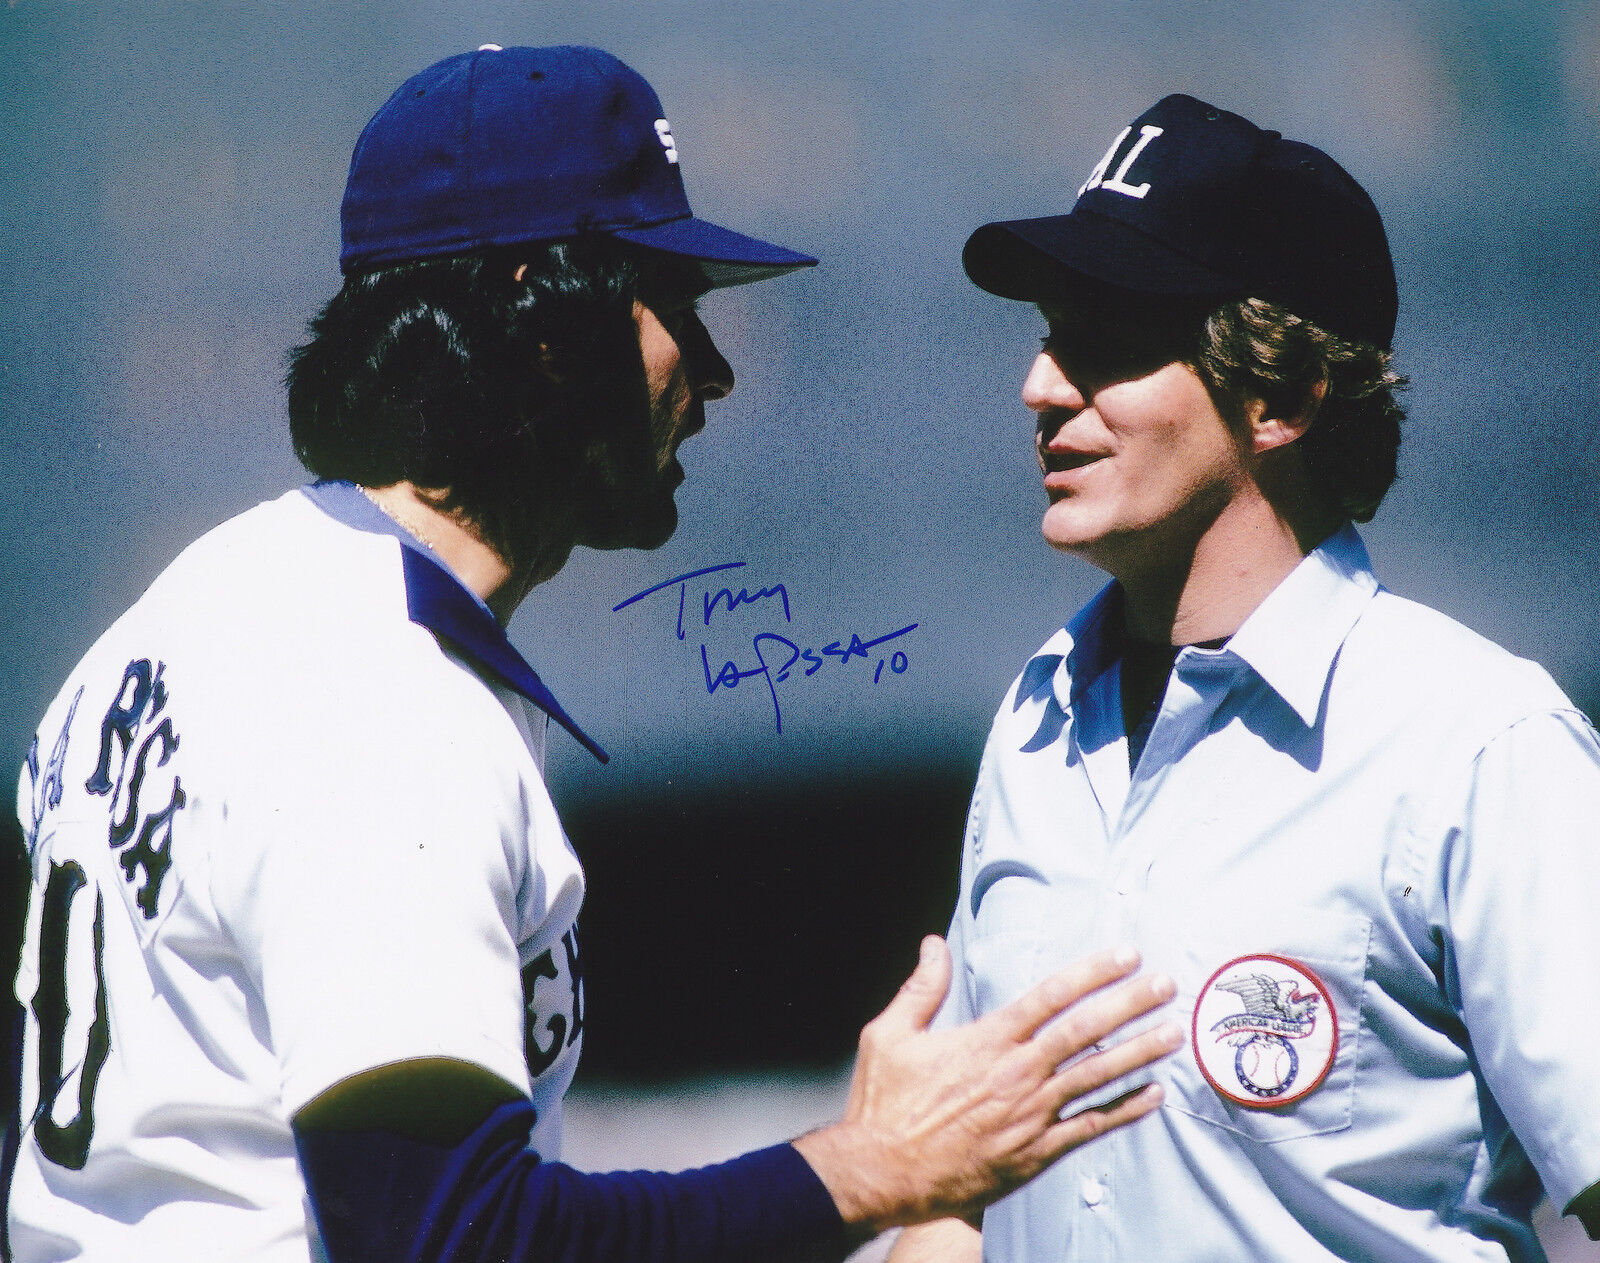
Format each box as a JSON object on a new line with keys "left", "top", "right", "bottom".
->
{"left": 285, "top": 235, "right": 693, "bottom": 559}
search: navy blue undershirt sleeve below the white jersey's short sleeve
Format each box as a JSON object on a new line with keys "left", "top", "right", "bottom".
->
{"left": 294, "top": 1101, "right": 859, "bottom": 1263}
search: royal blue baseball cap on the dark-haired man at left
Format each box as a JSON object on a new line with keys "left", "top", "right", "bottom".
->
{"left": 339, "top": 45, "right": 816, "bottom": 287}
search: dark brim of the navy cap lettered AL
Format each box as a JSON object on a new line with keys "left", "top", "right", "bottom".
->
{"left": 962, "top": 210, "right": 1242, "bottom": 303}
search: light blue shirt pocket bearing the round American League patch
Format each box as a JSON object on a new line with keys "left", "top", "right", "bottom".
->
{"left": 1162, "top": 908, "right": 1371, "bottom": 1145}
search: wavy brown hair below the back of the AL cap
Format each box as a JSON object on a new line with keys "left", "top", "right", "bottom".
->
{"left": 1189, "top": 298, "right": 1406, "bottom": 522}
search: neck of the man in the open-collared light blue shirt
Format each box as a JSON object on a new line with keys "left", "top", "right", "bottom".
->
{"left": 1114, "top": 495, "right": 1338, "bottom": 645}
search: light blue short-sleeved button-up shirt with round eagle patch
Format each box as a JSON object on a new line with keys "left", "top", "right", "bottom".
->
{"left": 944, "top": 527, "right": 1600, "bottom": 1263}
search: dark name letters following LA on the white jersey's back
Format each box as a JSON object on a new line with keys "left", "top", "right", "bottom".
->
{"left": 83, "top": 658, "right": 189, "bottom": 920}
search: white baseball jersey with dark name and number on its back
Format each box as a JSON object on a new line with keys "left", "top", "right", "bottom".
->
{"left": 8, "top": 483, "right": 584, "bottom": 1263}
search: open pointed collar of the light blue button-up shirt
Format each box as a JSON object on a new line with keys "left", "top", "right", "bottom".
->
{"left": 1049, "top": 522, "right": 1378, "bottom": 728}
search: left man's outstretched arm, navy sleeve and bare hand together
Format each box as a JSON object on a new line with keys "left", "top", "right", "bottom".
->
{"left": 294, "top": 940, "right": 1182, "bottom": 1263}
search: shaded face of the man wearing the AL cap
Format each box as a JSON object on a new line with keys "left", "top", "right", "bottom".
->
{"left": 1022, "top": 303, "right": 1250, "bottom": 576}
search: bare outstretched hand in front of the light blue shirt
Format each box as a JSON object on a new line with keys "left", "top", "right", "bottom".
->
{"left": 795, "top": 938, "right": 1184, "bottom": 1233}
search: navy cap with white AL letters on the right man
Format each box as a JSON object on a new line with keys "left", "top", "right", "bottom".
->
{"left": 962, "top": 94, "right": 1398, "bottom": 349}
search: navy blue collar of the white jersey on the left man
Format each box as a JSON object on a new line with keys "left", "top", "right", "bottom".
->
{"left": 301, "top": 480, "right": 611, "bottom": 764}
